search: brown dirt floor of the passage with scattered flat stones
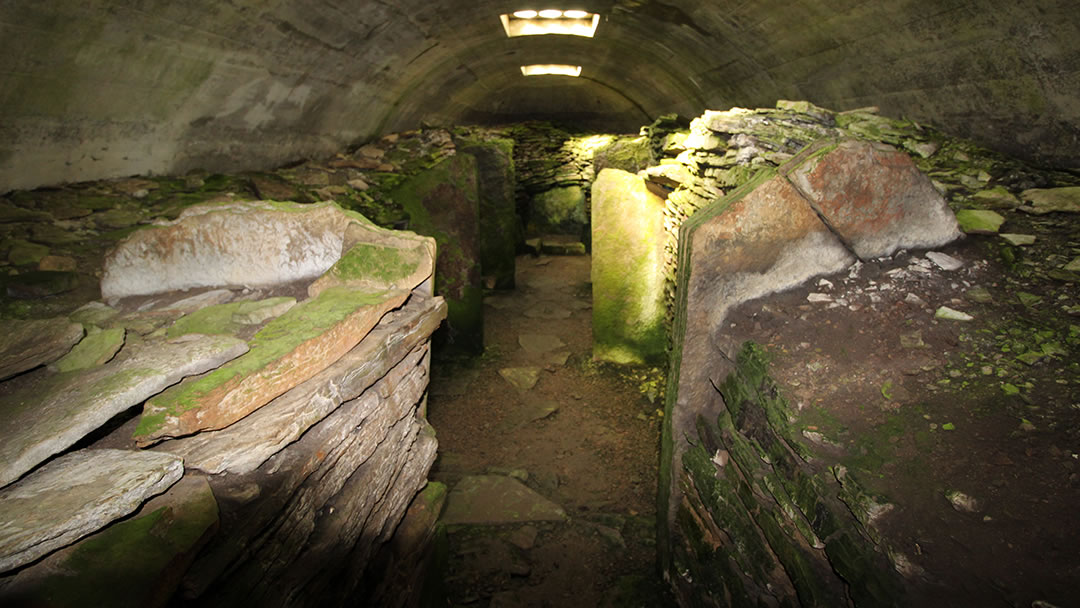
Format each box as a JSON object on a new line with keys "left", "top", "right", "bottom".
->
{"left": 429, "top": 256, "right": 671, "bottom": 607}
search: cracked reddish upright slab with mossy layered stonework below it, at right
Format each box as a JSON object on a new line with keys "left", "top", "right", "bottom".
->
{"left": 660, "top": 139, "right": 960, "bottom": 606}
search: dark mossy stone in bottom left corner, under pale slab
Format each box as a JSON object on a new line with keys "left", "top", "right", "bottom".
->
{"left": 0, "top": 475, "right": 219, "bottom": 608}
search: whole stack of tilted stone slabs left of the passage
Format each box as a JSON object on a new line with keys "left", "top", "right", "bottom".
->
{"left": 0, "top": 201, "right": 446, "bottom": 606}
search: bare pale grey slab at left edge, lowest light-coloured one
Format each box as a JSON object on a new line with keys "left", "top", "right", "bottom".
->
{"left": 0, "top": 449, "right": 184, "bottom": 572}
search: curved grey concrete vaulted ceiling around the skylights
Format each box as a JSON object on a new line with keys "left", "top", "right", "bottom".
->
{"left": 0, "top": 0, "right": 1080, "bottom": 192}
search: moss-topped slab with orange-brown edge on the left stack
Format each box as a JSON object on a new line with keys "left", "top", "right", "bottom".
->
{"left": 135, "top": 287, "right": 409, "bottom": 447}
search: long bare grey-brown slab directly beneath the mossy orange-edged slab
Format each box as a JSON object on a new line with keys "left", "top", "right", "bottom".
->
{"left": 154, "top": 298, "right": 446, "bottom": 474}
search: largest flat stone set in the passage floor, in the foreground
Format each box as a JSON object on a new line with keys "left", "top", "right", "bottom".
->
{"left": 442, "top": 475, "right": 567, "bottom": 525}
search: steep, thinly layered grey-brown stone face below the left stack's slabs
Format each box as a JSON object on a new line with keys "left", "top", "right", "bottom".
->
{"left": 186, "top": 346, "right": 437, "bottom": 607}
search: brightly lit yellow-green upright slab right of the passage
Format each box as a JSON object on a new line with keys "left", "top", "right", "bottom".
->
{"left": 592, "top": 168, "right": 667, "bottom": 364}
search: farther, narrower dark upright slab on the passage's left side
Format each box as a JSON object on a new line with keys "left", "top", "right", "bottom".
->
{"left": 458, "top": 138, "right": 524, "bottom": 289}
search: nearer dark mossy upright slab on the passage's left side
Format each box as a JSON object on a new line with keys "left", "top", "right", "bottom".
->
{"left": 390, "top": 153, "right": 484, "bottom": 354}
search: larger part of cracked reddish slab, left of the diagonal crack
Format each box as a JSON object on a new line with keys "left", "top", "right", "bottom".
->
{"left": 660, "top": 171, "right": 854, "bottom": 583}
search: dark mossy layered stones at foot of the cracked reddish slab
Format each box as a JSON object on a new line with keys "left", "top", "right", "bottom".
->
{"left": 666, "top": 342, "right": 903, "bottom": 607}
